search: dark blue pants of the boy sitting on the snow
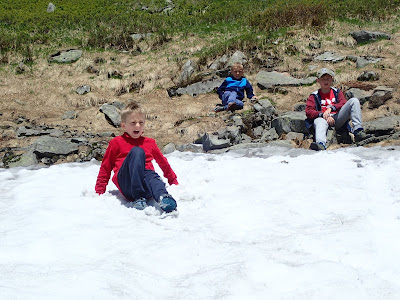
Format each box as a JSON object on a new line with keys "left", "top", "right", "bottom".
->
{"left": 117, "top": 147, "right": 168, "bottom": 201}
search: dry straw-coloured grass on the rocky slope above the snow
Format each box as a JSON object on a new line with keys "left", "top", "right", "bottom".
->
{"left": 0, "top": 19, "right": 400, "bottom": 147}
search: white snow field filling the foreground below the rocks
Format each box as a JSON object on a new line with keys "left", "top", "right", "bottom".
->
{"left": 0, "top": 147, "right": 400, "bottom": 300}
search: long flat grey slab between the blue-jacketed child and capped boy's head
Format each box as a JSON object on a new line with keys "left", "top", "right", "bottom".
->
{"left": 256, "top": 71, "right": 317, "bottom": 90}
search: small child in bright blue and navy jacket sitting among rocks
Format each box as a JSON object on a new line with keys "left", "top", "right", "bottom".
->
{"left": 215, "top": 63, "right": 257, "bottom": 112}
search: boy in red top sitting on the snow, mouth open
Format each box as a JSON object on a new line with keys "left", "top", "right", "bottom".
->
{"left": 95, "top": 102, "right": 178, "bottom": 212}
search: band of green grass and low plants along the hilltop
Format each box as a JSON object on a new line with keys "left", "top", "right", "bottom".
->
{"left": 0, "top": 0, "right": 400, "bottom": 60}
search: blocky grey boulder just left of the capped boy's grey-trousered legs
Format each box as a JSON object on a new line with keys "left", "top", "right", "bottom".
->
{"left": 271, "top": 112, "right": 306, "bottom": 136}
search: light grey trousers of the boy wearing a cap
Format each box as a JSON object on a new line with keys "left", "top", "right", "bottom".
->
{"left": 314, "top": 98, "right": 362, "bottom": 145}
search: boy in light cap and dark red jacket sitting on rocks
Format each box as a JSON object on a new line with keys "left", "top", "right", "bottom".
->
{"left": 306, "top": 68, "right": 371, "bottom": 151}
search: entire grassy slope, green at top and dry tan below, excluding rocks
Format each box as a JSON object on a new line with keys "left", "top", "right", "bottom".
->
{"left": 0, "top": 0, "right": 400, "bottom": 152}
